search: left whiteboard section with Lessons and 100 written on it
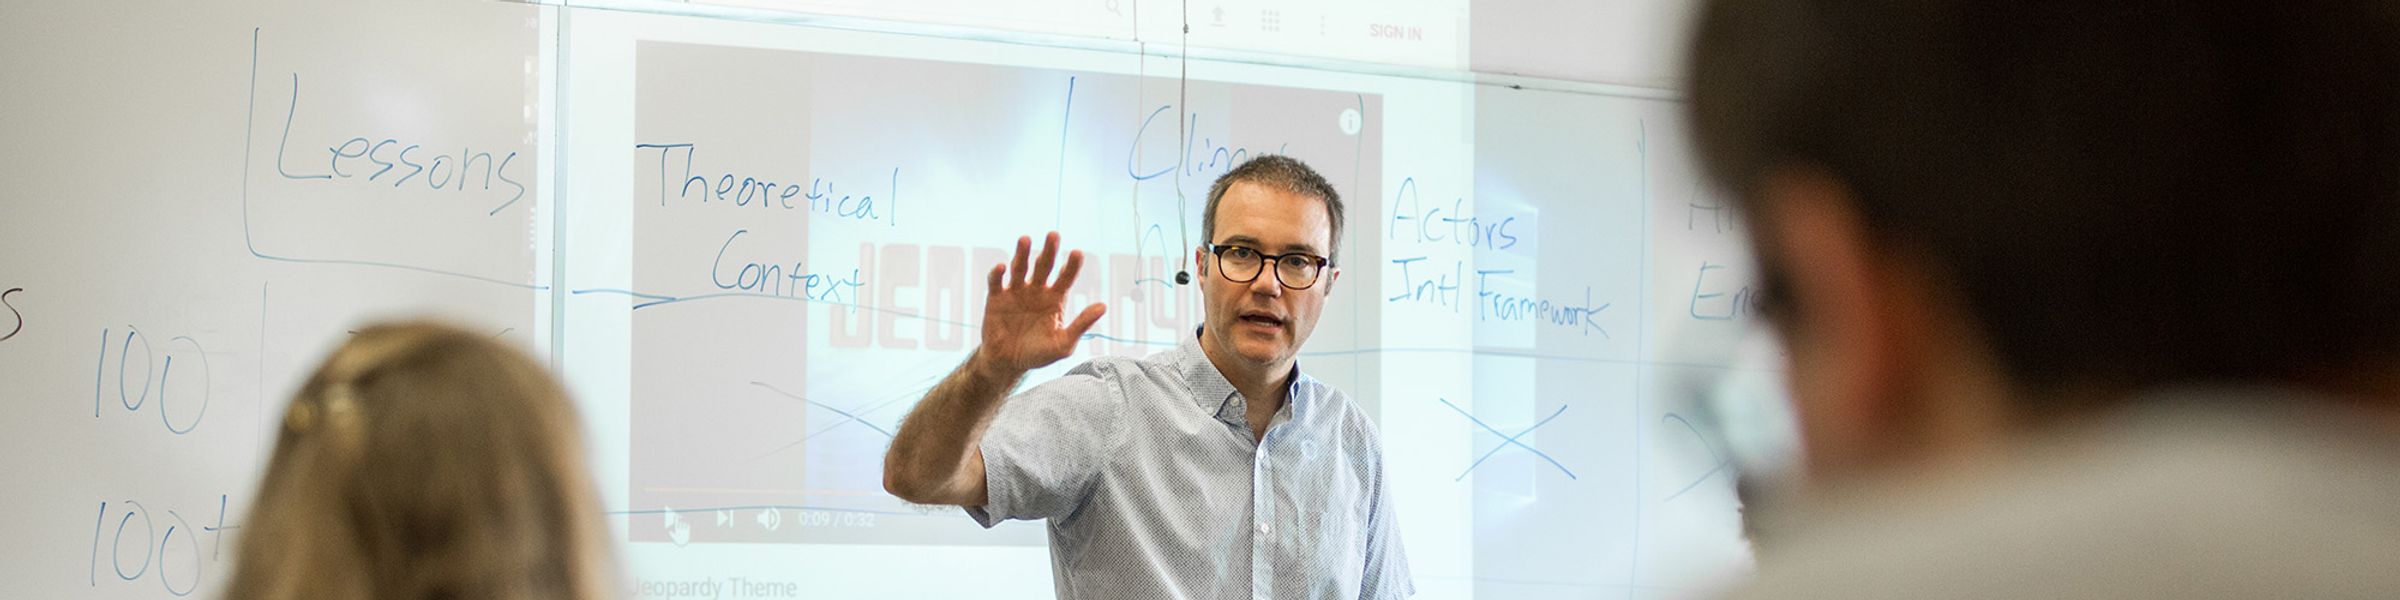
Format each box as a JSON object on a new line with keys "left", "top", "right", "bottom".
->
{"left": 0, "top": 2, "right": 552, "bottom": 598}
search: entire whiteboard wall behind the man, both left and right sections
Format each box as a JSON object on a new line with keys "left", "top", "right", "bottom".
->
{"left": 0, "top": 0, "right": 1776, "bottom": 598}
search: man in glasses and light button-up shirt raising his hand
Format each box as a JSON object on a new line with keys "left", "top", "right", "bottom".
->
{"left": 883, "top": 156, "right": 1414, "bottom": 600}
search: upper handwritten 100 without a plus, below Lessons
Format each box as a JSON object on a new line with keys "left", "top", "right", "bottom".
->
{"left": 91, "top": 326, "right": 214, "bottom": 434}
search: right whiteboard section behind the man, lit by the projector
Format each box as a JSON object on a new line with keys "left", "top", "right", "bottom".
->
{"left": 562, "top": 5, "right": 1771, "bottom": 598}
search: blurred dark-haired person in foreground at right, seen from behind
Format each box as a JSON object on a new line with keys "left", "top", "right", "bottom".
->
{"left": 1690, "top": 0, "right": 2400, "bottom": 598}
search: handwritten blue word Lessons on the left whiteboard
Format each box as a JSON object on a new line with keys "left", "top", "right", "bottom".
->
{"left": 276, "top": 72, "right": 526, "bottom": 216}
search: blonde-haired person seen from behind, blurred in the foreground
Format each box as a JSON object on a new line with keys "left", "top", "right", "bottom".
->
{"left": 226, "top": 324, "right": 617, "bottom": 600}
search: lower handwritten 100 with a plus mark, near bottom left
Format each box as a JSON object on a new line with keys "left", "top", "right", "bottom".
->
{"left": 84, "top": 497, "right": 226, "bottom": 595}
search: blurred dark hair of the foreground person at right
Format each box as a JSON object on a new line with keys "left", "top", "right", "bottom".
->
{"left": 1690, "top": 0, "right": 2400, "bottom": 394}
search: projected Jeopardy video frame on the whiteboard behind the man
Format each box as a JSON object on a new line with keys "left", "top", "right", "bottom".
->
{"left": 619, "top": 41, "right": 1382, "bottom": 545}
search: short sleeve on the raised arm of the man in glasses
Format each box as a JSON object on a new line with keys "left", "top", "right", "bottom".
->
{"left": 967, "top": 360, "right": 1126, "bottom": 528}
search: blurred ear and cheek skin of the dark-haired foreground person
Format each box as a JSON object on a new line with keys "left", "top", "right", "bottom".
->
{"left": 1752, "top": 168, "right": 1925, "bottom": 475}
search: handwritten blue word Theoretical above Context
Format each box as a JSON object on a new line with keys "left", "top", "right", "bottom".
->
{"left": 634, "top": 144, "right": 900, "bottom": 226}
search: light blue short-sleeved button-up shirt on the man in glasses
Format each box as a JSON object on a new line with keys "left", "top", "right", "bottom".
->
{"left": 967, "top": 328, "right": 1416, "bottom": 600}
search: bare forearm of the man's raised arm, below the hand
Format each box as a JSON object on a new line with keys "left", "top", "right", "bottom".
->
{"left": 883, "top": 350, "right": 1025, "bottom": 506}
